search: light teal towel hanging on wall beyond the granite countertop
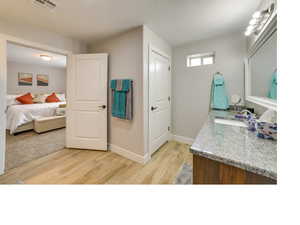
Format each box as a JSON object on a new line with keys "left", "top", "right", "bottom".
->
{"left": 211, "top": 74, "right": 229, "bottom": 110}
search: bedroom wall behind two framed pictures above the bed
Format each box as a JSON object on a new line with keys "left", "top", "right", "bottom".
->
{"left": 7, "top": 62, "right": 66, "bottom": 94}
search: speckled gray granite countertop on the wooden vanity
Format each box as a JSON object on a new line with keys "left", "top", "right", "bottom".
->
{"left": 190, "top": 111, "right": 277, "bottom": 180}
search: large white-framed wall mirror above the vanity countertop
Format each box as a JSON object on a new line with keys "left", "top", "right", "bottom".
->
{"left": 245, "top": 11, "right": 277, "bottom": 110}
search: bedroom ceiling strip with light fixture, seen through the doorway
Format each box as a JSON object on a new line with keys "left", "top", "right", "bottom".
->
{"left": 7, "top": 43, "right": 67, "bottom": 68}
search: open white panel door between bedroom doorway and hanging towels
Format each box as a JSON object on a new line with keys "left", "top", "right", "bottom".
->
{"left": 66, "top": 54, "right": 108, "bottom": 150}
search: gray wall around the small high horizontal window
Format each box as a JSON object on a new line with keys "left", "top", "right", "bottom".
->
{"left": 172, "top": 31, "right": 246, "bottom": 138}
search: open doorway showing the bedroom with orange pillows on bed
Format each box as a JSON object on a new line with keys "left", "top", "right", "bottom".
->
{"left": 5, "top": 42, "right": 67, "bottom": 170}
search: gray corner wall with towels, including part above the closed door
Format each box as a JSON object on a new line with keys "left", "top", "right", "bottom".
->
{"left": 88, "top": 26, "right": 172, "bottom": 158}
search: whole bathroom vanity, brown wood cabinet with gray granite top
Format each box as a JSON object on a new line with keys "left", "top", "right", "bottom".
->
{"left": 190, "top": 111, "right": 277, "bottom": 184}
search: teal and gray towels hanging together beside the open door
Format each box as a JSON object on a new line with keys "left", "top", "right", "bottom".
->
{"left": 110, "top": 80, "right": 132, "bottom": 120}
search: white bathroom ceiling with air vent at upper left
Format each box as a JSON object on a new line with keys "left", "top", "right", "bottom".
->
{"left": 0, "top": 0, "right": 261, "bottom": 45}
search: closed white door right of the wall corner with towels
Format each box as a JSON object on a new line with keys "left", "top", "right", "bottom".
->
{"left": 149, "top": 49, "right": 171, "bottom": 154}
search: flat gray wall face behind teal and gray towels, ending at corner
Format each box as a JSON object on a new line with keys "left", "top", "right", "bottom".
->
{"left": 89, "top": 27, "right": 144, "bottom": 156}
